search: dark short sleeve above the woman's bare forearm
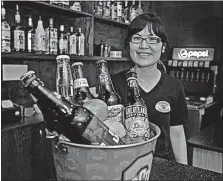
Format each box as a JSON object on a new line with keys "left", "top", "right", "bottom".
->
{"left": 170, "top": 83, "right": 188, "bottom": 126}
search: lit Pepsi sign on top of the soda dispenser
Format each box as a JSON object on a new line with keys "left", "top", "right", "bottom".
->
{"left": 172, "top": 48, "right": 214, "bottom": 61}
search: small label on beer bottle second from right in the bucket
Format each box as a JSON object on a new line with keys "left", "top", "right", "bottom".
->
{"left": 107, "top": 104, "right": 124, "bottom": 122}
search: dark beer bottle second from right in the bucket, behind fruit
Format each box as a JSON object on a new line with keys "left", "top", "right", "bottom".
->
{"left": 96, "top": 60, "right": 123, "bottom": 122}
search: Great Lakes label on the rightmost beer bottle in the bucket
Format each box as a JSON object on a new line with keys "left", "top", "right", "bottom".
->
{"left": 123, "top": 105, "right": 149, "bottom": 139}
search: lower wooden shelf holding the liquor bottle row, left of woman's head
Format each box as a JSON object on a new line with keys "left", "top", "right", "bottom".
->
{"left": 1, "top": 52, "right": 129, "bottom": 63}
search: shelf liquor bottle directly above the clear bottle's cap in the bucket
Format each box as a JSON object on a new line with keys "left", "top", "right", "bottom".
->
{"left": 58, "top": 25, "right": 68, "bottom": 55}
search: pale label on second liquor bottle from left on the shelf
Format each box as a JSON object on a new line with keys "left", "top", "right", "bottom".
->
{"left": 14, "top": 30, "right": 25, "bottom": 50}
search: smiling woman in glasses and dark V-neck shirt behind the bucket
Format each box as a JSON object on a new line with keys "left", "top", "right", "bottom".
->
{"left": 112, "top": 13, "right": 188, "bottom": 164}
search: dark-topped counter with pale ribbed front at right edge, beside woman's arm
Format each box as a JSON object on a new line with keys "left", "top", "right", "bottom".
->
{"left": 187, "top": 120, "right": 223, "bottom": 173}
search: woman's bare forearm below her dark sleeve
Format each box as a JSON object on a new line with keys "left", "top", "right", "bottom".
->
{"left": 170, "top": 125, "right": 187, "bottom": 165}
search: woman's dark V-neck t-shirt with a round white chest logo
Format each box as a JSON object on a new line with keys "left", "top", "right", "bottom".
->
{"left": 112, "top": 70, "right": 188, "bottom": 160}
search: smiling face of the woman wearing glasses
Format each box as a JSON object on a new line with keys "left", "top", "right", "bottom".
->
{"left": 129, "top": 26, "right": 163, "bottom": 67}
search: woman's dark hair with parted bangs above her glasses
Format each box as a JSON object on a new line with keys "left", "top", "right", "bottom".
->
{"left": 125, "top": 13, "right": 168, "bottom": 47}
